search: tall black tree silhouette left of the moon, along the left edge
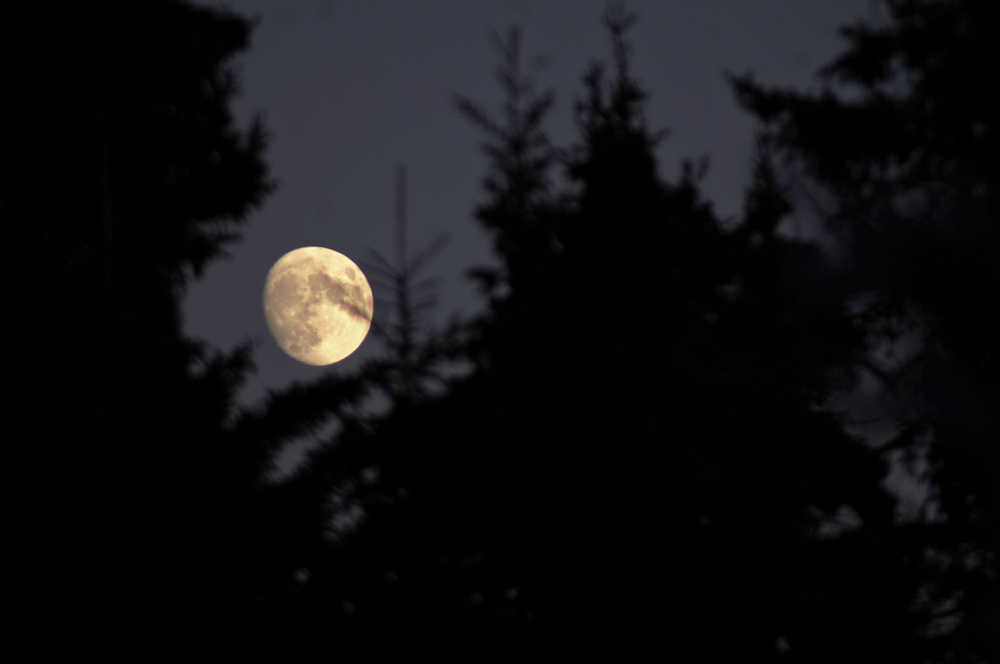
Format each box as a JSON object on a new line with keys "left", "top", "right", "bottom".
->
{"left": 10, "top": 2, "right": 272, "bottom": 629}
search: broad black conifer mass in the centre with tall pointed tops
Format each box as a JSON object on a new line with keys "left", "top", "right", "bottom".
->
{"left": 250, "top": 11, "right": 936, "bottom": 661}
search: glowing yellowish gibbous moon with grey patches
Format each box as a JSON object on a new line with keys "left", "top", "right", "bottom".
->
{"left": 264, "top": 247, "right": 374, "bottom": 366}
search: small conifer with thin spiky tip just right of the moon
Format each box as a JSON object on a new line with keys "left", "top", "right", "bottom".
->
{"left": 236, "top": 163, "right": 462, "bottom": 631}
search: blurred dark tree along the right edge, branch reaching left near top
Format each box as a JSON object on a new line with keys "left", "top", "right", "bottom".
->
{"left": 734, "top": 0, "right": 1000, "bottom": 661}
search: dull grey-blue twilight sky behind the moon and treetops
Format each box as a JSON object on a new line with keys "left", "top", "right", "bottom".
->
{"left": 184, "top": 0, "right": 874, "bottom": 403}
